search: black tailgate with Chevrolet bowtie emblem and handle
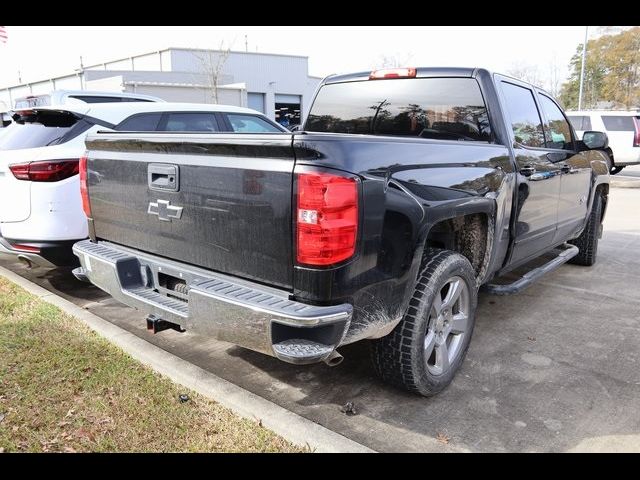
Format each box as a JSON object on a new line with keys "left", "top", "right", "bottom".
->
{"left": 87, "top": 133, "right": 294, "bottom": 288}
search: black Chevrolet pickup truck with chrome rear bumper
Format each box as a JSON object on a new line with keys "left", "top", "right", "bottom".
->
{"left": 74, "top": 68, "right": 609, "bottom": 395}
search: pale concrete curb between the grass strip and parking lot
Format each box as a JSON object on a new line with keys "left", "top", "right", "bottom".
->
{"left": 0, "top": 266, "right": 375, "bottom": 453}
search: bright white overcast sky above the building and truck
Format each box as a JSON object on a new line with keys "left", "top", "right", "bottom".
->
{"left": 0, "top": 26, "right": 597, "bottom": 88}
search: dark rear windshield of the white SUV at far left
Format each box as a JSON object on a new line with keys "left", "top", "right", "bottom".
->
{"left": 0, "top": 112, "right": 88, "bottom": 150}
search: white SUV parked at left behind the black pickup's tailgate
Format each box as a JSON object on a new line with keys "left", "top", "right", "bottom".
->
{"left": 0, "top": 102, "right": 287, "bottom": 267}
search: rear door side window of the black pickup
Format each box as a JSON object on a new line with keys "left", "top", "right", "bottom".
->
{"left": 502, "top": 82, "right": 544, "bottom": 148}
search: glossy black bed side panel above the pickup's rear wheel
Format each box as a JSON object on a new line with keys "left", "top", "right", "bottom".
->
{"left": 293, "top": 133, "right": 515, "bottom": 343}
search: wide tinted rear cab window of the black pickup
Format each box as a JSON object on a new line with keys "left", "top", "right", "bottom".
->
{"left": 304, "top": 77, "right": 491, "bottom": 142}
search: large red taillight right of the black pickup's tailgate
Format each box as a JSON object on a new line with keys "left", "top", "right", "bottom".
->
{"left": 296, "top": 173, "right": 358, "bottom": 265}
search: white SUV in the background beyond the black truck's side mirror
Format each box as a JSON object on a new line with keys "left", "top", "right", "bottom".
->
{"left": 567, "top": 110, "right": 640, "bottom": 174}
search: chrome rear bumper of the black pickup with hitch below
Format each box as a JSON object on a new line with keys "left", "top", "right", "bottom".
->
{"left": 73, "top": 240, "right": 353, "bottom": 363}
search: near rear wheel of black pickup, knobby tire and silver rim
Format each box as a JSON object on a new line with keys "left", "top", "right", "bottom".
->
{"left": 371, "top": 249, "right": 478, "bottom": 396}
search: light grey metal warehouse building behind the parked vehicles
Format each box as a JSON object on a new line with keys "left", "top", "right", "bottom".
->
{"left": 0, "top": 48, "right": 320, "bottom": 124}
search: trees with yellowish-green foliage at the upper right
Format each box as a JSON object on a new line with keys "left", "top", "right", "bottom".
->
{"left": 560, "top": 27, "right": 640, "bottom": 109}
